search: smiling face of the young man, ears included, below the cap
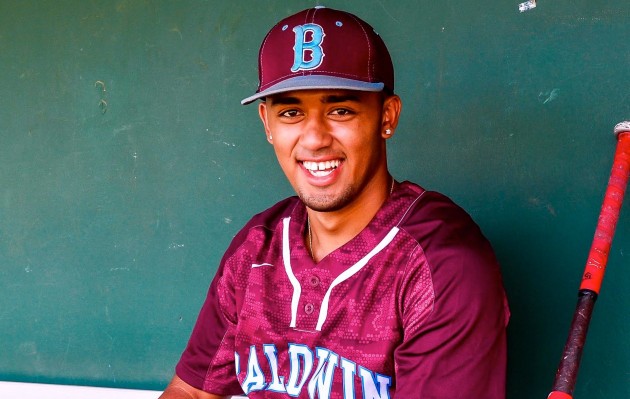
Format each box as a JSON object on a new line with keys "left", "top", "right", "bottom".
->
{"left": 259, "top": 90, "right": 400, "bottom": 216}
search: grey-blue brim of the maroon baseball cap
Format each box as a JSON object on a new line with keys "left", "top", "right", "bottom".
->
{"left": 241, "top": 75, "right": 385, "bottom": 105}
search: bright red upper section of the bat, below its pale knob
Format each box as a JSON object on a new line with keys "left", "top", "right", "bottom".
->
{"left": 580, "top": 131, "right": 630, "bottom": 294}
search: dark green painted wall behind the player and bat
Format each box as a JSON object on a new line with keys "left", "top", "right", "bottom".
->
{"left": 0, "top": 0, "right": 630, "bottom": 399}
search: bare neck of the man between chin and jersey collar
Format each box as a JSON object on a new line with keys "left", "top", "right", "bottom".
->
{"left": 306, "top": 174, "right": 394, "bottom": 262}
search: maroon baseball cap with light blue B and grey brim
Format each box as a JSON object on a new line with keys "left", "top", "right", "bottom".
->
{"left": 241, "top": 6, "right": 394, "bottom": 104}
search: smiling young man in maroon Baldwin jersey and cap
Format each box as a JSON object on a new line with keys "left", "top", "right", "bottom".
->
{"left": 162, "top": 7, "right": 509, "bottom": 399}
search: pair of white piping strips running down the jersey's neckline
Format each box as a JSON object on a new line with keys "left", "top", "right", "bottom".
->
{"left": 282, "top": 217, "right": 400, "bottom": 331}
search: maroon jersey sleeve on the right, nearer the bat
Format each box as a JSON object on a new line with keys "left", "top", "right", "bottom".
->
{"left": 394, "top": 192, "right": 509, "bottom": 399}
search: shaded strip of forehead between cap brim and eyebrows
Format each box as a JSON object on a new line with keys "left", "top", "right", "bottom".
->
{"left": 266, "top": 89, "right": 381, "bottom": 105}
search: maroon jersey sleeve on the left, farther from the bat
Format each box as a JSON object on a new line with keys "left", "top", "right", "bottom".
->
{"left": 175, "top": 197, "right": 299, "bottom": 396}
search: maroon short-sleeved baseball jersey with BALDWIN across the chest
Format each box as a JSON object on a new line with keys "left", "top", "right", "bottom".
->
{"left": 176, "top": 182, "right": 509, "bottom": 399}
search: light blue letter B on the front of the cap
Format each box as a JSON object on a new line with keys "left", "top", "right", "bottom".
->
{"left": 291, "top": 24, "right": 326, "bottom": 72}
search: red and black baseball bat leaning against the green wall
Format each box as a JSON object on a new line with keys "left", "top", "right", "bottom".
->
{"left": 547, "top": 121, "right": 630, "bottom": 399}
